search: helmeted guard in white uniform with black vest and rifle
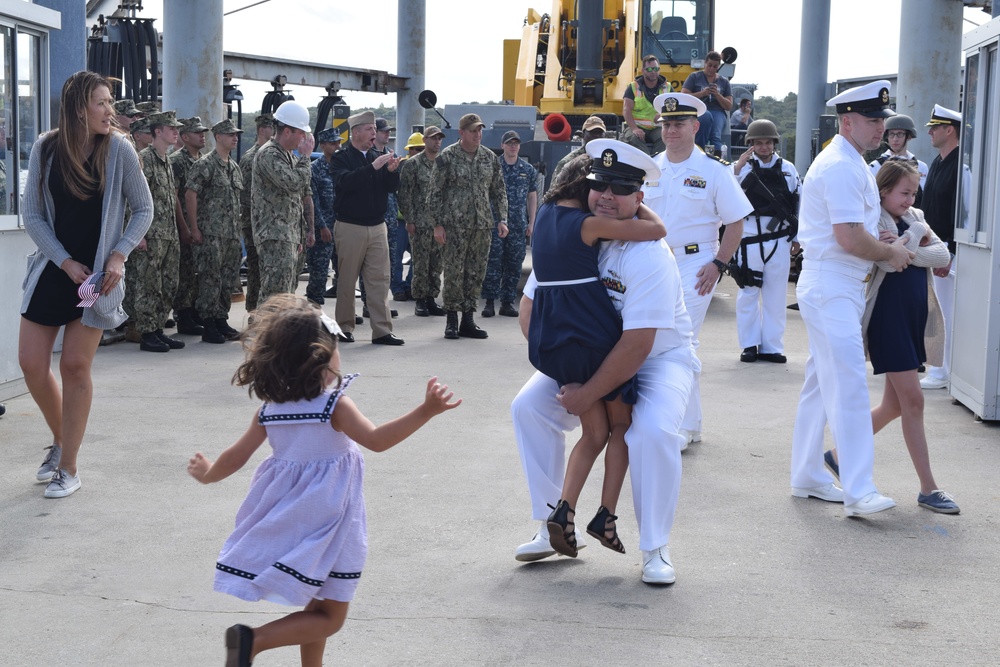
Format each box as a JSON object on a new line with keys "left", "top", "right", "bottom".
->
{"left": 731, "top": 119, "right": 799, "bottom": 364}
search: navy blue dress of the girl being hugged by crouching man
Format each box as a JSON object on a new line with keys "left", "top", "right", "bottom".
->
{"left": 528, "top": 202, "right": 638, "bottom": 405}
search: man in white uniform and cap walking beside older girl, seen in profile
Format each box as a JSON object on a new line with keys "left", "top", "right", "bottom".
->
{"left": 791, "top": 81, "right": 913, "bottom": 516}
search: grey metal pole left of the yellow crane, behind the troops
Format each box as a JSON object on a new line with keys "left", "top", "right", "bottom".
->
{"left": 396, "top": 0, "right": 427, "bottom": 154}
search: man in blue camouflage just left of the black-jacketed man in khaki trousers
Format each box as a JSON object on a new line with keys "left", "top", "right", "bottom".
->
{"left": 306, "top": 127, "right": 341, "bottom": 305}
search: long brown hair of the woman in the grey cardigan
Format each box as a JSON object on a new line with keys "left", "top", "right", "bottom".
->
{"left": 41, "top": 71, "right": 114, "bottom": 201}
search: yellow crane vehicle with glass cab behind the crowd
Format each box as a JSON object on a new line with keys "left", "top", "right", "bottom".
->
{"left": 503, "top": 0, "right": 736, "bottom": 140}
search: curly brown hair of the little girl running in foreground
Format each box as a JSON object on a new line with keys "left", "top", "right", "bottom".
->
{"left": 233, "top": 294, "right": 341, "bottom": 403}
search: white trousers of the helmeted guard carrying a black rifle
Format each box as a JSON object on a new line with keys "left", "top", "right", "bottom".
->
{"left": 736, "top": 238, "right": 792, "bottom": 354}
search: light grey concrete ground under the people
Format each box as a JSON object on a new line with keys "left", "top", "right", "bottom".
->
{"left": 0, "top": 279, "right": 1000, "bottom": 667}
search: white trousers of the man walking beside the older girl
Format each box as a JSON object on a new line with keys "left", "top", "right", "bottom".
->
{"left": 791, "top": 260, "right": 876, "bottom": 505}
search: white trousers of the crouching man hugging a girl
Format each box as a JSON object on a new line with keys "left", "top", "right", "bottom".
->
{"left": 510, "top": 348, "right": 697, "bottom": 551}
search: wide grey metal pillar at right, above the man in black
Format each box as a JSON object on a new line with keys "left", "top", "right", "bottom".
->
{"left": 893, "top": 0, "right": 963, "bottom": 164}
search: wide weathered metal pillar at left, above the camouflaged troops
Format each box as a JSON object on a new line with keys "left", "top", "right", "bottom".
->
{"left": 163, "top": 0, "right": 223, "bottom": 127}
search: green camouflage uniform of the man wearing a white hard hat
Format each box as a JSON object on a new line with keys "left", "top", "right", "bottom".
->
{"left": 250, "top": 139, "right": 312, "bottom": 305}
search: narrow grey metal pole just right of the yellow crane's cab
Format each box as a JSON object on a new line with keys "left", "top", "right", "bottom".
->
{"left": 795, "top": 0, "right": 830, "bottom": 174}
